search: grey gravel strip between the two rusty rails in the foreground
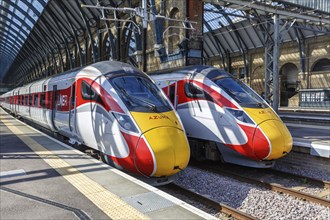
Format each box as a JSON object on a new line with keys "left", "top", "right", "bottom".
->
{"left": 175, "top": 167, "right": 330, "bottom": 219}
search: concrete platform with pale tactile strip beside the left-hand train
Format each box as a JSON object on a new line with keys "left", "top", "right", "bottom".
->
{"left": 0, "top": 109, "right": 214, "bottom": 219}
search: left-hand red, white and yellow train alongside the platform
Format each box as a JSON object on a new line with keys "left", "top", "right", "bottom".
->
{"left": 0, "top": 61, "right": 190, "bottom": 182}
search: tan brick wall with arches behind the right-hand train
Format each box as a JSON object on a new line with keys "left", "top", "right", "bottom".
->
{"left": 208, "top": 36, "right": 330, "bottom": 107}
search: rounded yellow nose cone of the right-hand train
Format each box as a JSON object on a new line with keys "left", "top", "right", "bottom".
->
{"left": 253, "top": 120, "right": 292, "bottom": 160}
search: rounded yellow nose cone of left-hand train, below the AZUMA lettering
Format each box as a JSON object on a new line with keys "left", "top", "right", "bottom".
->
{"left": 136, "top": 127, "right": 190, "bottom": 177}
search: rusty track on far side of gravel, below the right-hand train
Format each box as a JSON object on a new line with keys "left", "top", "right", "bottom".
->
{"left": 190, "top": 164, "right": 330, "bottom": 207}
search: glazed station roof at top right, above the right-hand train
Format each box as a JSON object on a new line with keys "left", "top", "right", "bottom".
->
{"left": 203, "top": 0, "right": 330, "bottom": 58}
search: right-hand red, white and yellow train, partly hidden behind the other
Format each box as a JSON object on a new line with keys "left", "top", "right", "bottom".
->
{"left": 151, "top": 66, "right": 292, "bottom": 167}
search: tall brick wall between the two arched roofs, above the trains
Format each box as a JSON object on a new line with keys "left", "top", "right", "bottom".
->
{"left": 147, "top": 0, "right": 203, "bottom": 72}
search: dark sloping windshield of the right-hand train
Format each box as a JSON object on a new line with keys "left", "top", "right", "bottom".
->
{"left": 213, "top": 77, "right": 267, "bottom": 108}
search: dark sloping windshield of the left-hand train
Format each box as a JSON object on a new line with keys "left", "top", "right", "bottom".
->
{"left": 110, "top": 76, "right": 172, "bottom": 112}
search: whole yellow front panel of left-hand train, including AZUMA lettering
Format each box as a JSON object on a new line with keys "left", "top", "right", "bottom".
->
{"left": 131, "top": 111, "right": 190, "bottom": 177}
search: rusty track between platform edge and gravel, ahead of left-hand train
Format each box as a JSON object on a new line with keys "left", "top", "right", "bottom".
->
{"left": 159, "top": 183, "right": 257, "bottom": 220}
